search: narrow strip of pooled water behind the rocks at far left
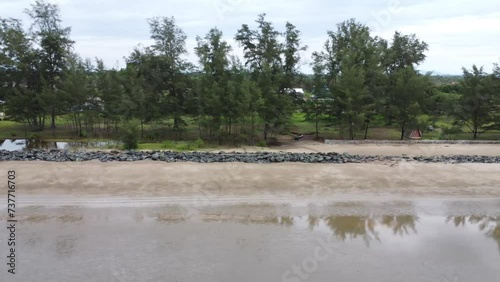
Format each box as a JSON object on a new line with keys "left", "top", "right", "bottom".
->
{"left": 0, "top": 139, "right": 118, "bottom": 151}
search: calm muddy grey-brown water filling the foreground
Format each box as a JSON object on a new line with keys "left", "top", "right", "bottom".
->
{"left": 0, "top": 200, "right": 500, "bottom": 282}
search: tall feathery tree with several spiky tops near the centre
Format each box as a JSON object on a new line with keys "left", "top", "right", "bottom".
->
{"left": 235, "top": 14, "right": 304, "bottom": 139}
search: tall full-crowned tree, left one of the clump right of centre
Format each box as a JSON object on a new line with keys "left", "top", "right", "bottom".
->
{"left": 315, "top": 19, "right": 380, "bottom": 139}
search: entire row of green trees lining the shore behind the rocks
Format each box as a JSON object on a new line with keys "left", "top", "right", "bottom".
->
{"left": 0, "top": 1, "right": 500, "bottom": 144}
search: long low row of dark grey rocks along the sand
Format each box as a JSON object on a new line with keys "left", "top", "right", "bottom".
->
{"left": 0, "top": 150, "right": 500, "bottom": 163}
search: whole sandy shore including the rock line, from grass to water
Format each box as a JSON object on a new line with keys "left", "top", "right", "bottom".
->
{"left": 0, "top": 142, "right": 500, "bottom": 202}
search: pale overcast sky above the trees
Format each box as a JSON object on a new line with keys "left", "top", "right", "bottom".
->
{"left": 0, "top": 0, "right": 500, "bottom": 74}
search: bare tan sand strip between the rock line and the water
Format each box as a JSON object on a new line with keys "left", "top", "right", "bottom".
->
{"left": 0, "top": 161, "right": 500, "bottom": 199}
